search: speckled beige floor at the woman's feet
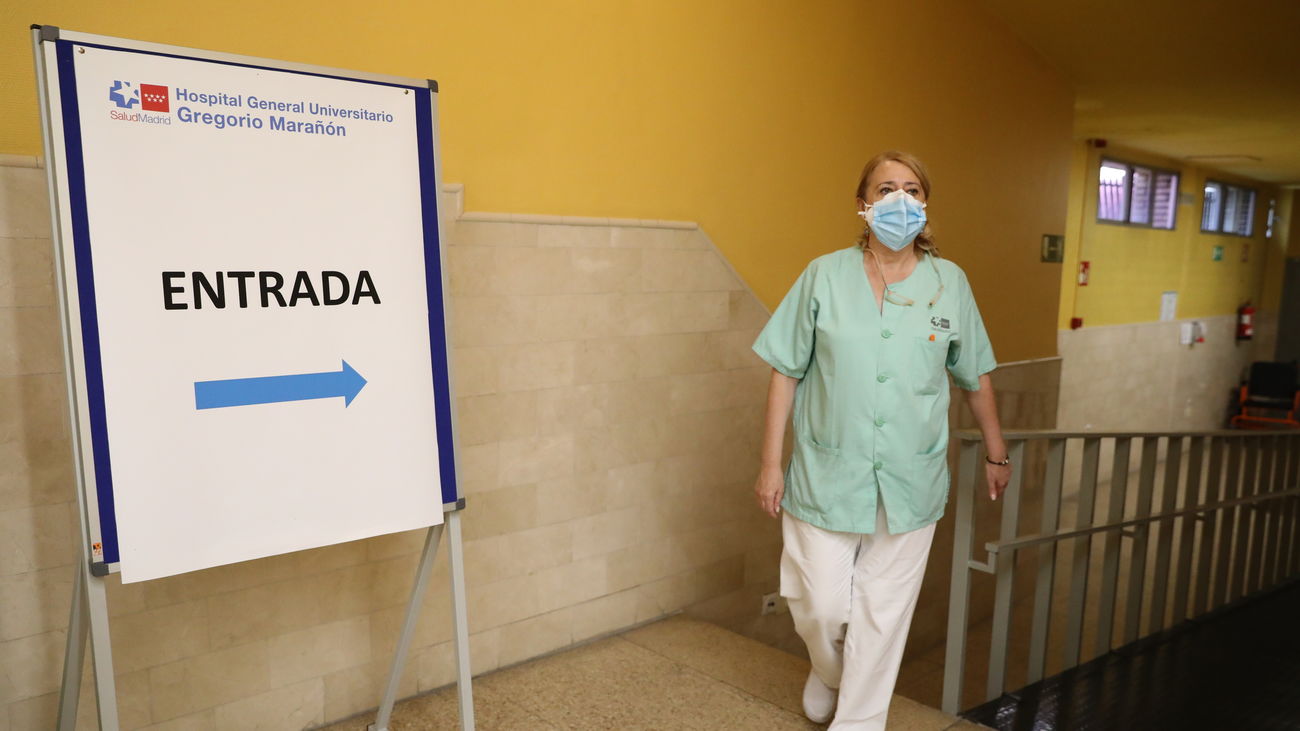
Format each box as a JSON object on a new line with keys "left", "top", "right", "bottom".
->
{"left": 326, "top": 617, "right": 983, "bottom": 731}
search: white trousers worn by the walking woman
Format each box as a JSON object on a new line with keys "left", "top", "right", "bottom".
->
{"left": 781, "top": 506, "right": 935, "bottom": 731}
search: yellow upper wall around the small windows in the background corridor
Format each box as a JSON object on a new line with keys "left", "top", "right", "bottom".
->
{"left": 1060, "top": 142, "right": 1282, "bottom": 328}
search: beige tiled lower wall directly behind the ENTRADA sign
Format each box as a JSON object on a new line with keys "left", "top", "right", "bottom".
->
{"left": 0, "top": 159, "right": 779, "bottom": 731}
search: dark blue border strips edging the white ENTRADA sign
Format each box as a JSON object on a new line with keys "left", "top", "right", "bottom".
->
{"left": 55, "top": 40, "right": 460, "bottom": 563}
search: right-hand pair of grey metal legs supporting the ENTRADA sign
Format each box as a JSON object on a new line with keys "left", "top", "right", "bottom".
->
{"left": 368, "top": 498, "right": 475, "bottom": 731}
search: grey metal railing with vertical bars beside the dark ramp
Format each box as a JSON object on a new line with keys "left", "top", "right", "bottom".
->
{"left": 943, "top": 429, "right": 1300, "bottom": 713}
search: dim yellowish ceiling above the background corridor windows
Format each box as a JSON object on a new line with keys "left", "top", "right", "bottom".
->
{"left": 979, "top": 0, "right": 1300, "bottom": 186}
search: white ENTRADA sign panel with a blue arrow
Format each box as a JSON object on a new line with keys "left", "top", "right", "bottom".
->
{"left": 56, "top": 42, "right": 450, "bottom": 581}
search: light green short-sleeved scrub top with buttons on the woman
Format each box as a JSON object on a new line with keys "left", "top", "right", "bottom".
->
{"left": 754, "top": 246, "right": 997, "bottom": 533}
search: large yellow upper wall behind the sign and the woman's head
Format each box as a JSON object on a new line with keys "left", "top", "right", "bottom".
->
{"left": 0, "top": 0, "right": 1073, "bottom": 362}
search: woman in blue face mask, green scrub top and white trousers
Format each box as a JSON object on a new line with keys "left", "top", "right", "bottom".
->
{"left": 754, "top": 152, "right": 1011, "bottom": 730}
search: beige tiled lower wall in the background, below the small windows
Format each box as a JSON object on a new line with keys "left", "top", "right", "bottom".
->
{"left": 1057, "top": 315, "right": 1277, "bottom": 432}
